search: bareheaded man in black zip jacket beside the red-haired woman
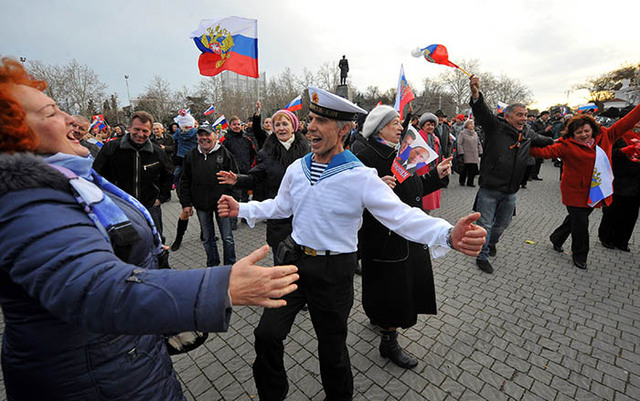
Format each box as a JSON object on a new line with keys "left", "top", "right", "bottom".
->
{"left": 93, "top": 111, "right": 173, "bottom": 242}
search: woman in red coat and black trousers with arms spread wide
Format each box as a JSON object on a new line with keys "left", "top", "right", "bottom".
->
{"left": 530, "top": 106, "right": 640, "bottom": 269}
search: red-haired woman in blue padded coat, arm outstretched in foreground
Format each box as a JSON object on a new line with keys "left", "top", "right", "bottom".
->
{"left": 0, "top": 58, "right": 297, "bottom": 401}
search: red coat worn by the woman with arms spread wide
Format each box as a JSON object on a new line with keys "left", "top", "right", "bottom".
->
{"left": 530, "top": 105, "right": 640, "bottom": 207}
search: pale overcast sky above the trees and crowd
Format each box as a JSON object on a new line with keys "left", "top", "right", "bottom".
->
{"left": 0, "top": 0, "right": 640, "bottom": 108}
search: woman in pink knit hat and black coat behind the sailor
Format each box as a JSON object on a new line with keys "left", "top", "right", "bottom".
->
{"left": 218, "top": 110, "right": 311, "bottom": 258}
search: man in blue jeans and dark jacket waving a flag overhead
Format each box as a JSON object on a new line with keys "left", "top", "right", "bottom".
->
{"left": 469, "top": 76, "right": 553, "bottom": 273}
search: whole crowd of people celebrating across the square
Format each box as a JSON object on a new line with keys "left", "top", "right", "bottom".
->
{"left": 0, "top": 54, "right": 640, "bottom": 400}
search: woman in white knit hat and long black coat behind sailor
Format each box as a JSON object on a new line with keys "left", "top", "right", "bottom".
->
{"left": 357, "top": 106, "right": 451, "bottom": 368}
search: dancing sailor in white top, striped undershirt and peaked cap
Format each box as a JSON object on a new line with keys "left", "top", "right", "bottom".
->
{"left": 218, "top": 87, "right": 486, "bottom": 401}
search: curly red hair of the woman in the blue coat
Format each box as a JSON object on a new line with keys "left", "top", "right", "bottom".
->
{"left": 0, "top": 57, "right": 47, "bottom": 153}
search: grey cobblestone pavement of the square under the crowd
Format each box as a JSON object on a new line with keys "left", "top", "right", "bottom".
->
{"left": 2, "top": 162, "right": 640, "bottom": 401}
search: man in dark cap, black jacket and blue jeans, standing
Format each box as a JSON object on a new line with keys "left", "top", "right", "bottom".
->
{"left": 178, "top": 125, "right": 238, "bottom": 267}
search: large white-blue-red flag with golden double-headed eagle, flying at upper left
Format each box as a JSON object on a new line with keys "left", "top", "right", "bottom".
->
{"left": 190, "top": 17, "right": 259, "bottom": 78}
